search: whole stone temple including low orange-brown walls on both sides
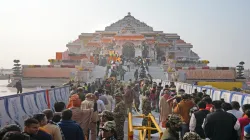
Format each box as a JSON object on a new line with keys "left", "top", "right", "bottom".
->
{"left": 17, "top": 13, "right": 244, "bottom": 87}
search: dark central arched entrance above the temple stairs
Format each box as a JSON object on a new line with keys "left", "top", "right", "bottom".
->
{"left": 122, "top": 42, "right": 135, "bottom": 59}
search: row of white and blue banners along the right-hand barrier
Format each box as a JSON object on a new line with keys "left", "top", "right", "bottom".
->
{"left": 153, "top": 79, "right": 250, "bottom": 106}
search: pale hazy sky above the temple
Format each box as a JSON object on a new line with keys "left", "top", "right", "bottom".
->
{"left": 0, "top": 0, "right": 250, "bottom": 68}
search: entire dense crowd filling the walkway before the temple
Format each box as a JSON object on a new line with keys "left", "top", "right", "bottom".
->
{"left": 3, "top": 68, "right": 250, "bottom": 140}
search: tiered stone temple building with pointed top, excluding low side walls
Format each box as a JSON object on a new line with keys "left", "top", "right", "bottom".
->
{"left": 53, "top": 13, "right": 200, "bottom": 62}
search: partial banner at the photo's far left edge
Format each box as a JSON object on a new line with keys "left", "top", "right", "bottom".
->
{"left": 0, "top": 97, "right": 14, "bottom": 128}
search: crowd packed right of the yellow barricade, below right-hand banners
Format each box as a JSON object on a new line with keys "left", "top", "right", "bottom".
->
{"left": 159, "top": 86, "right": 250, "bottom": 140}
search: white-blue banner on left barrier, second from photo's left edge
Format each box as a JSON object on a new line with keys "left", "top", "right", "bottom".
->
{"left": 5, "top": 95, "right": 29, "bottom": 128}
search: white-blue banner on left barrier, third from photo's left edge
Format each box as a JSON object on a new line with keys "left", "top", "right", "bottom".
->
{"left": 20, "top": 92, "right": 40, "bottom": 117}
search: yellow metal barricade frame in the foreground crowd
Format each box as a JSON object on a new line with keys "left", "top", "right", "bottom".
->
{"left": 128, "top": 113, "right": 163, "bottom": 140}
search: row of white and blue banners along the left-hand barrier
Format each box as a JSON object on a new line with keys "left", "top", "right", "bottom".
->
{"left": 0, "top": 86, "right": 70, "bottom": 128}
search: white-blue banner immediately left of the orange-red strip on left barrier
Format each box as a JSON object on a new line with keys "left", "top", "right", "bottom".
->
{"left": 34, "top": 90, "right": 48, "bottom": 112}
